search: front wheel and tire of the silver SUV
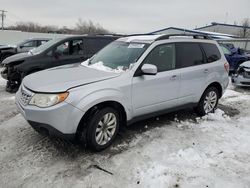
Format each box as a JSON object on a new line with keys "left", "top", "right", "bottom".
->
{"left": 80, "top": 107, "right": 120, "bottom": 151}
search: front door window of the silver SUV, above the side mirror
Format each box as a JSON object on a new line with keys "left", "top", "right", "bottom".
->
{"left": 143, "top": 44, "right": 175, "bottom": 72}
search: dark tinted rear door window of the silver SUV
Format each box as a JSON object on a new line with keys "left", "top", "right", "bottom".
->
{"left": 176, "top": 42, "right": 204, "bottom": 68}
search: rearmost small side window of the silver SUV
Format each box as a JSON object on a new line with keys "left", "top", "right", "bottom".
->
{"left": 201, "top": 43, "right": 221, "bottom": 63}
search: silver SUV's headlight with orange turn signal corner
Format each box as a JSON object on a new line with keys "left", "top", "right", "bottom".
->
{"left": 29, "top": 92, "right": 69, "bottom": 108}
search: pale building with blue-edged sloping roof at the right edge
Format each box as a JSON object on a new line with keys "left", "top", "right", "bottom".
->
{"left": 195, "top": 22, "right": 250, "bottom": 37}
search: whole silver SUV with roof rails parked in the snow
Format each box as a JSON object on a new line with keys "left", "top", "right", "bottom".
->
{"left": 16, "top": 35, "right": 229, "bottom": 151}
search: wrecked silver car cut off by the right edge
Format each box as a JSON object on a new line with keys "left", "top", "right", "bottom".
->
{"left": 231, "top": 61, "right": 250, "bottom": 87}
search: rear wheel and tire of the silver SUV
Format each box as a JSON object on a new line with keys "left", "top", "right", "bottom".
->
{"left": 196, "top": 86, "right": 219, "bottom": 116}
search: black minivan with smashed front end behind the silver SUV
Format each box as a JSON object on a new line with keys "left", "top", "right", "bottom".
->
{"left": 1, "top": 36, "right": 118, "bottom": 92}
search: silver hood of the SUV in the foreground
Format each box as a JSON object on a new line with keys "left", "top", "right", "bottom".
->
{"left": 23, "top": 64, "right": 121, "bottom": 93}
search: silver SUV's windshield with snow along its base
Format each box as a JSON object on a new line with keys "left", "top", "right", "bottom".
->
{"left": 88, "top": 41, "right": 148, "bottom": 70}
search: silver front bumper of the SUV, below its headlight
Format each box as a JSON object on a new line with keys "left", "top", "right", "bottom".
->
{"left": 16, "top": 86, "right": 84, "bottom": 137}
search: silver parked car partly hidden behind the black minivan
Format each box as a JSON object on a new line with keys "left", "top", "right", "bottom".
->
{"left": 0, "top": 38, "right": 51, "bottom": 63}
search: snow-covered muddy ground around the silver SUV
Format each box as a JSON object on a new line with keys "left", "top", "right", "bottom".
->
{"left": 0, "top": 68, "right": 250, "bottom": 188}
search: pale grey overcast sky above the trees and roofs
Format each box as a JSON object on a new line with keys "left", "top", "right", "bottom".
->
{"left": 0, "top": 0, "right": 250, "bottom": 33}
